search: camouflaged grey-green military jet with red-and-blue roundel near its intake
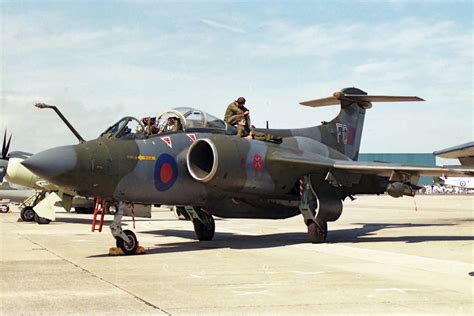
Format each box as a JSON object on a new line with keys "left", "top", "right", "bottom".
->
{"left": 23, "top": 88, "right": 474, "bottom": 254}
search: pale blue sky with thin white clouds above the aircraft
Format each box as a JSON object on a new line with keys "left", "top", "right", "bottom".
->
{"left": 0, "top": 0, "right": 474, "bottom": 157}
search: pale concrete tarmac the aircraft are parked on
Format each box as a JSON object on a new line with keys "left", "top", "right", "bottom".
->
{"left": 0, "top": 195, "right": 474, "bottom": 315}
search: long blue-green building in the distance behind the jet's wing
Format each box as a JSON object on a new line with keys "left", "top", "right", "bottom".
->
{"left": 359, "top": 153, "right": 436, "bottom": 185}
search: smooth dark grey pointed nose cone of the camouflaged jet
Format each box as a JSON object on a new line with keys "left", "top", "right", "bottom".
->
{"left": 22, "top": 146, "right": 77, "bottom": 184}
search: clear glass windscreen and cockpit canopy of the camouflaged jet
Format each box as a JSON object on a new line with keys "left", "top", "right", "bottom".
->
{"left": 101, "top": 107, "right": 229, "bottom": 139}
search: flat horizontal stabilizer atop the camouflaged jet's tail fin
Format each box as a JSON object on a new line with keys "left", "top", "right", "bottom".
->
{"left": 300, "top": 91, "right": 425, "bottom": 107}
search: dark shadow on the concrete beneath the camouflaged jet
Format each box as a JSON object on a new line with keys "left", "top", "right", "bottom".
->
{"left": 88, "top": 223, "right": 474, "bottom": 258}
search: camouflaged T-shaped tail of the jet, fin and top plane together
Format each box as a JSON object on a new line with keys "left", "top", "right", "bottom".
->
{"left": 300, "top": 88, "right": 424, "bottom": 160}
